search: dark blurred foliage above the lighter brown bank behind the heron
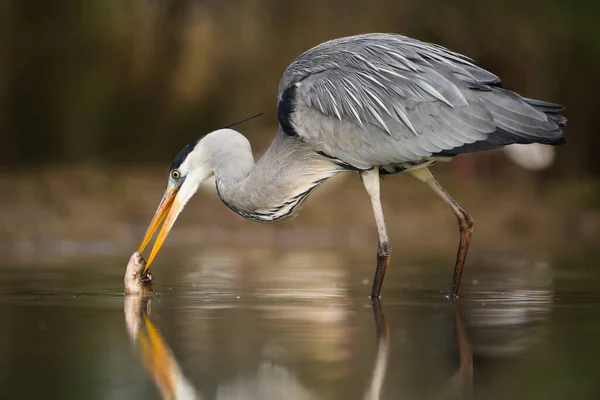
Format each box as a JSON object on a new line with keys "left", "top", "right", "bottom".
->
{"left": 0, "top": 0, "right": 600, "bottom": 176}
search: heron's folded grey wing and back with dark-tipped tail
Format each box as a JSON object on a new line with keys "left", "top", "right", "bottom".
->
{"left": 279, "top": 34, "right": 564, "bottom": 168}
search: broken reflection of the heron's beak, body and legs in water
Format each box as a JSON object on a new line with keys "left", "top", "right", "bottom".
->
{"left": 124, "top": 295, "right": 473, "bottom": 400}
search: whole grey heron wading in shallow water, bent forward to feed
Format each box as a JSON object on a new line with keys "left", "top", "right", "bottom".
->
{"left": 138, "top": 33, "right": 566, "bottom": 297}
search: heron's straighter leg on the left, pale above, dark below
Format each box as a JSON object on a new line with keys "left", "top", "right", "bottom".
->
{"left": 360, "top": 167, "right": 392, "bottom": 298}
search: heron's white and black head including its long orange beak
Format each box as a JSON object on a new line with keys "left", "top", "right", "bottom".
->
{"left": 138, "top": 139, "right": 213, "bottom": 273}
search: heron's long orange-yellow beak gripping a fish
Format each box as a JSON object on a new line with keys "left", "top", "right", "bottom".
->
{"left": 138, "top": 187, "right": 182, "bottom": 274}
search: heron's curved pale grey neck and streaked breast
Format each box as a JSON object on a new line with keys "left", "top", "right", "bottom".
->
{"left": 214, "top": 133, "right": 340, "bottom": 222}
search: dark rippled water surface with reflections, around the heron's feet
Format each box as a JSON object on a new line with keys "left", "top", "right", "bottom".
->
{"left": 0, "top": 248, "right": 600, "bottom": 399}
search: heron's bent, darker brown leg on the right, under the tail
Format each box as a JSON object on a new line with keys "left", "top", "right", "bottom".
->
{"left": 411, "top": 168, "right": 473, "bottom": 299}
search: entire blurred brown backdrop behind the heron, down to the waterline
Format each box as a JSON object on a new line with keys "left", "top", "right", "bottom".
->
{"left": 0, "top": 0, "right": 600, "bottom": 262}
